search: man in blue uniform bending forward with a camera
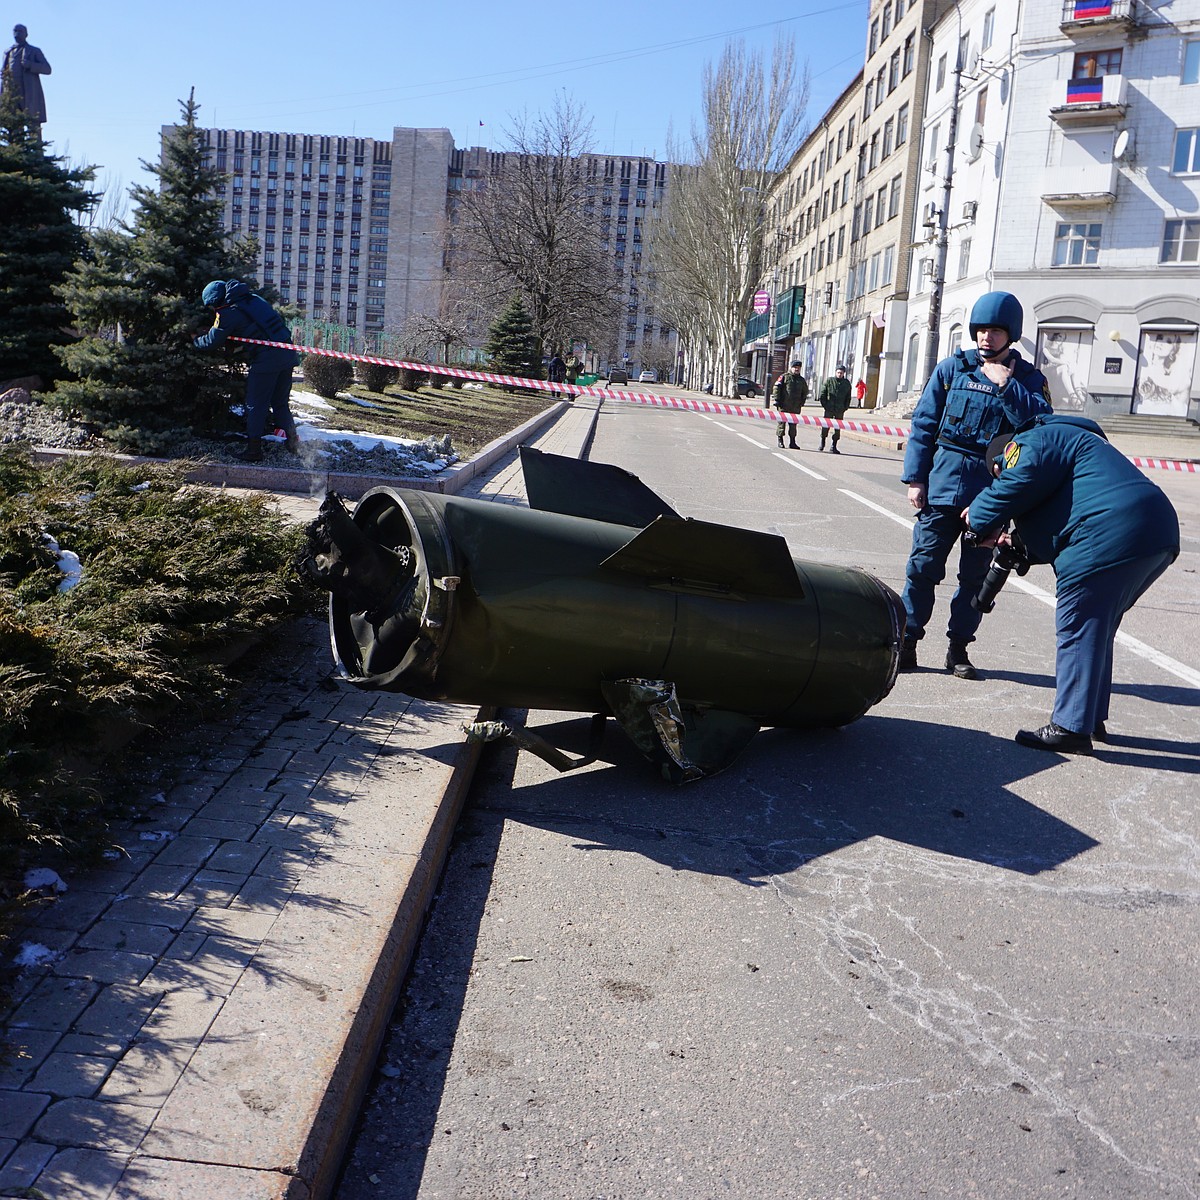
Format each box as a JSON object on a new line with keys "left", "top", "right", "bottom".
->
{"left": 962, "top": 413, "right": 1180, "bottom": 754}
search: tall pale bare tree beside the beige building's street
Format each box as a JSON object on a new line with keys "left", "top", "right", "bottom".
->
{"left": 653, "top": 38, "right": 809, "bottom": 395}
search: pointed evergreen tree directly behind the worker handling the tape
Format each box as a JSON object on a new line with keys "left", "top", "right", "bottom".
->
{"left": 53, "top": 92, "right": 256, "bottom": 451}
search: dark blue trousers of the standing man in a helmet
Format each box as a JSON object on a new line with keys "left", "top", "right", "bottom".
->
{"left": 901, "top": 504, "right": 991, "bottom": 643}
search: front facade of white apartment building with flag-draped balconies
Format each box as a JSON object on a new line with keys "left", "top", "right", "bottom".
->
{"left": 994, "top": 0, "right": 1200, "bottom": 419}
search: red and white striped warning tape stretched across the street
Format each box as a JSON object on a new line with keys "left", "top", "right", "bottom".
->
{"left": 230, "top": 337, "right": 1200, "bottom": 474}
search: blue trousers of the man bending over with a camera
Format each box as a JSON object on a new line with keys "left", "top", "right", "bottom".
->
{"left": 1050, "top": 550, "right": 1175, "bottom": 736}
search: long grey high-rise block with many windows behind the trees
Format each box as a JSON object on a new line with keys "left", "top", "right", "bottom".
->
{"left": 184, "top": 126, "right": 674, "bottom": 368}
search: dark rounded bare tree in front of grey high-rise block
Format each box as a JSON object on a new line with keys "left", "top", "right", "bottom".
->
{"left": 451, "top": 95, "right": 618, "bottom": 360}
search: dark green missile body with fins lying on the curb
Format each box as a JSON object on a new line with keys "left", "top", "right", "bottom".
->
{"left": 300, "top": 451, "right": 904, "bottom": 781}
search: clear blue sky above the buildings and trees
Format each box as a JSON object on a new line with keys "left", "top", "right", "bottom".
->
{"left": 16, "top": 0, "right": 868, "bottom": 202}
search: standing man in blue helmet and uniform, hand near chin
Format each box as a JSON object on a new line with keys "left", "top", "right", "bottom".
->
{"left": 900, "top": 292, "right": 1050, "bottom": 679}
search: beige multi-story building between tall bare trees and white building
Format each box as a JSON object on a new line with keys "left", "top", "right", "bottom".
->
{"left": 772, "top": 0, "right": 950, "bottom": 406}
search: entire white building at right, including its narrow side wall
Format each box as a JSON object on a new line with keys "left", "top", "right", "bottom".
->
{"left": 904, "top": 0, "right": 1200, "bottom": 419}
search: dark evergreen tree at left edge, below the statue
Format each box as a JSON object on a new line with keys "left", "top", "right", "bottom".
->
{"left": 0, "top": 88, "right": 100, "bottom": 383}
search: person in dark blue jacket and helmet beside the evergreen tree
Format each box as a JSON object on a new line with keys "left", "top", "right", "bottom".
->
{"left": 192, "top": 280, "right": 300, "bottom": 462}
